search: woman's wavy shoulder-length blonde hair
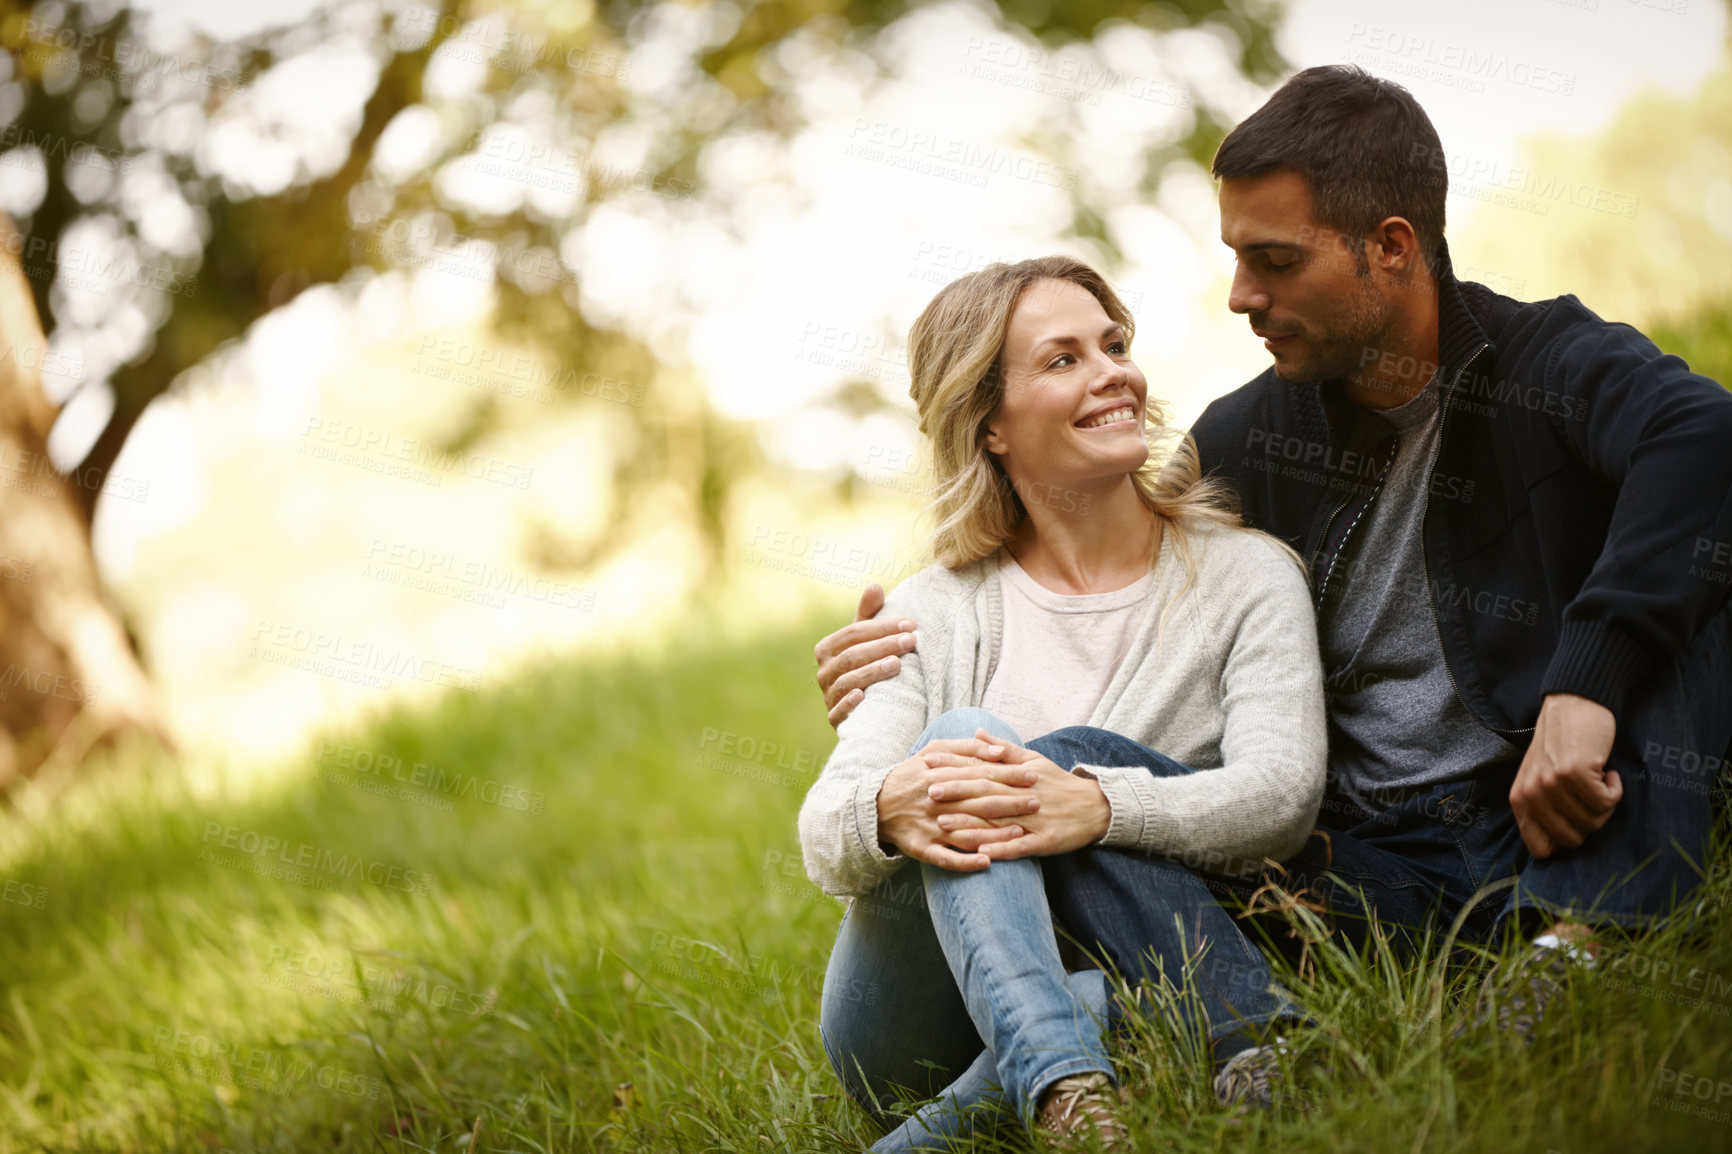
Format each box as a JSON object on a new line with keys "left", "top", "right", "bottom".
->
{"left": 908, "top": 256, "right": 1267, "bottom": 586}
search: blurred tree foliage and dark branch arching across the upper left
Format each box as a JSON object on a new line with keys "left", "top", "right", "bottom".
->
{"left": 0, "top": 0, "right": 1283, "bottom": 565}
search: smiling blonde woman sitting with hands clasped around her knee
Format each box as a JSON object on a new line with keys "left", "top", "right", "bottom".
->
{"left": 800, "top": 256, "right": 1325, "bottom": 1151}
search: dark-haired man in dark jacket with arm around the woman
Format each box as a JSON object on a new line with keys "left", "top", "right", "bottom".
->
{"left": 816, "top": 66, "right": 1732, "bottom": 1097}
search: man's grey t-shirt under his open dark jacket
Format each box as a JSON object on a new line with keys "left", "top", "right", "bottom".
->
{"left": 1318, "top": 378, "right": 1517, "bottom": 813}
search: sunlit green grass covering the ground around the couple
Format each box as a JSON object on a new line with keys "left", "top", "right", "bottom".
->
{"left": 0, "top": 626, "right": 1732, "bottom": 1154}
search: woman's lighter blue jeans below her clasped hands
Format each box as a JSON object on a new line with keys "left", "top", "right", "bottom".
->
{"left": 819, "top": 709, "right": 1112, "bottom": 1151}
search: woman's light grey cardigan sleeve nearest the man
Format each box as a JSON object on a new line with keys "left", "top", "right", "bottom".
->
{"left": 1077, "top": 534, "right": 1328, "bottom": 875}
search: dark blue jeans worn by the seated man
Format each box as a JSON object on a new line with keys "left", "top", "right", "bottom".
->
{"left": 1036, "top": 610, "right": 1732, "bottom": 1018}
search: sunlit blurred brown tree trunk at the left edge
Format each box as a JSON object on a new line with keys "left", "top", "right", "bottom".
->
{"left": 0, "top": 213, "right": 165, "bottom": 792}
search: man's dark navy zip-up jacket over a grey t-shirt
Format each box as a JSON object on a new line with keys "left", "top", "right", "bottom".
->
{"left": 1192, "top": 258, "right": 1732, "bottom": 743}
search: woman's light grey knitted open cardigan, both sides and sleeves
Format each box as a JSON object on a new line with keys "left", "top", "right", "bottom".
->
{"left": 800, "top": 525, "right": 1327, "bottom": 896}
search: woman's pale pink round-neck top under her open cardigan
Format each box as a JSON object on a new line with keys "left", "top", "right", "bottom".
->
{"left": 980, "top": 551, "right": 1155, "bottom": 742}
